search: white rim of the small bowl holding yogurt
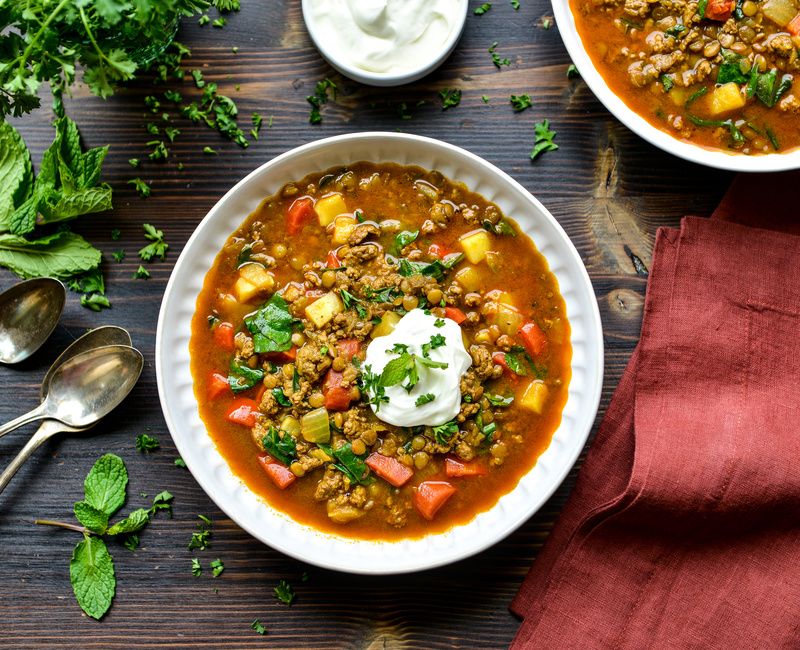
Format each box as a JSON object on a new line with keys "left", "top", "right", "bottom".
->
{"left": 302, "top": 0, "right": 469, "bottom": 87}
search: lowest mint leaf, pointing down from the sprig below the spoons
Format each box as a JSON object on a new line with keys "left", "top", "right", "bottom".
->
{"left": 69, "top": 536, "right": 117, "bottom": 620}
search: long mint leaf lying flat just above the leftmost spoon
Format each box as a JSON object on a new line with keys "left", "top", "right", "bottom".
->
{"left": 0, "top": 231, "right": 100, "bottom": 278}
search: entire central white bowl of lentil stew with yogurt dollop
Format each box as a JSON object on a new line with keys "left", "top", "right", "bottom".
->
{"left": 156, "top": 133, "right": 602, "bottom": 573}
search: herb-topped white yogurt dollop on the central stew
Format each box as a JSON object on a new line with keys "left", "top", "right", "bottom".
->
{"left": 363, "top": 309, "right": 472, "bottom": 427}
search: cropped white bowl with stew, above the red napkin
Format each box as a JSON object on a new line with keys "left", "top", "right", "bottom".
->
{"left": 552, "top": 0, "right": 800, "bottom": 172}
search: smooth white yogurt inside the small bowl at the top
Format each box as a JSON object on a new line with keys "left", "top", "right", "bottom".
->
{"left": 310, "top": 0, "right": 460, "bottom": 74}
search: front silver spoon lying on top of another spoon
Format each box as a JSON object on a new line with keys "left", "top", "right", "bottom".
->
{"left": 0, "top": 345, "right": 144, "bottom": 437}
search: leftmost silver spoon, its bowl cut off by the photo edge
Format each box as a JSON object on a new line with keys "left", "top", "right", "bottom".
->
{"left": 0, "top": 278, "right": 66, "bottom": 363}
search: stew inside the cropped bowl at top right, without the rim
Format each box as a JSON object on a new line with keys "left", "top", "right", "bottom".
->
{"left": 569, "top": 0, "right": 800, "bottom": 155}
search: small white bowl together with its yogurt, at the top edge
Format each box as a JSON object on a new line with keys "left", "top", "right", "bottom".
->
{"left": 302, "top": 0, "right": 468, "bottom": 86}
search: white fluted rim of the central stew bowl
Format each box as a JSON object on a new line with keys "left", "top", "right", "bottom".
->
{"left": 156, "top": 133, "right": 603, "bottom": 574}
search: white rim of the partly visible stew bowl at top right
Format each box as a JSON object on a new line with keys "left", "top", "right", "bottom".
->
{"left": 552, "top": 0, "right": 800, "bottom": 172}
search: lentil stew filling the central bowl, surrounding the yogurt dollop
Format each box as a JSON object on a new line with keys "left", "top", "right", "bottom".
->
{"left": 190, "top": 162, "right": 572, "bottom": 539}
